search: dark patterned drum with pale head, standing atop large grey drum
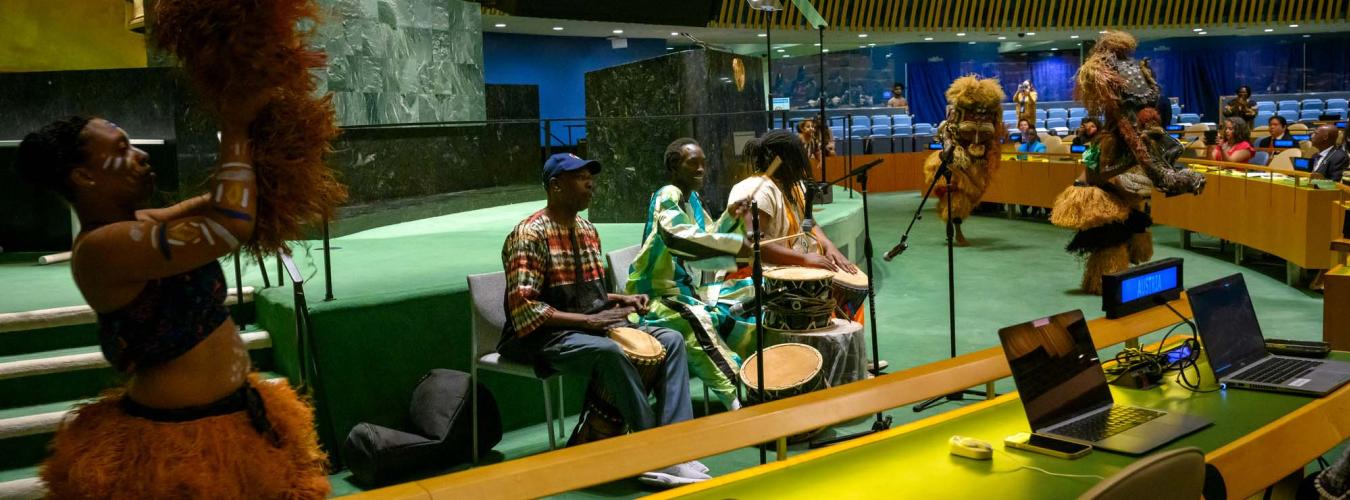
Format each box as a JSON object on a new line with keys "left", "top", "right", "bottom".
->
{"left": 764, "top": 268, "right": 834, "bottom": 330}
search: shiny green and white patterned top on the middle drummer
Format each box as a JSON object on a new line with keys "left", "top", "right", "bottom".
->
{"left": 625, "top": 185, "right": 744, "bottom": 297}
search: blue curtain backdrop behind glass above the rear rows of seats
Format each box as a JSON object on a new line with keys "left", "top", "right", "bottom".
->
{"left": 774, "top": 34, "right": 1350, "bottom": 123}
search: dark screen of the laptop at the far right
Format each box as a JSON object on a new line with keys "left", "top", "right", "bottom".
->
{"left": 1187, "top": 274, "right": 1266, "bottom": 377}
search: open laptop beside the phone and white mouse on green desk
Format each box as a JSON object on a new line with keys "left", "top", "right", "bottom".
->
{"left": 999, "top": 311, "right": 1211, "bottom": 455}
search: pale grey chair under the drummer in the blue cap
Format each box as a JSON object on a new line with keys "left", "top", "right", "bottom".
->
{"left": 468, "top": 272, "right": 567, "bottom": 464}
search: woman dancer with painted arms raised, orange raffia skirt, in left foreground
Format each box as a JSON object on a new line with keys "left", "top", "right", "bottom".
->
{"left": 18, "top": 0, "right": 346, "bottom": 499}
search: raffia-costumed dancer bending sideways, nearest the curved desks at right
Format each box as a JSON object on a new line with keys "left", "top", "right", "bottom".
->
{"left": 1050, "top": 31, "right": 1204, "bottom": 295}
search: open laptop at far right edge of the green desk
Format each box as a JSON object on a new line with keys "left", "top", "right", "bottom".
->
{"left": 1187, "top": 274, "right": 1350, "bottom": 396}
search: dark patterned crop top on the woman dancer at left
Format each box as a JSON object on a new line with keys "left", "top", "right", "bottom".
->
{"left": 99, "top": 261, "right": 230, "bottom": 372}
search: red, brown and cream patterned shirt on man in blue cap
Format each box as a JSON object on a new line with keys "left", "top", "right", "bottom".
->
{"left": 502, "top": 209, "right": 609, "bottom": 342}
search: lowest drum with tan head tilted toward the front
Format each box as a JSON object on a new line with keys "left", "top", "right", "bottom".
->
{"left": 741, "top": 343, "right": 825, "bottom": 403}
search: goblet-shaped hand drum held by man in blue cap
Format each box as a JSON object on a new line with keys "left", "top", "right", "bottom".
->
{"left": 567, "top": 327, "right": 666, "bottom": 446}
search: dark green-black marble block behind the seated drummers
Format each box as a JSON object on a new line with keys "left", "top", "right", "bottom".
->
{"left": 586, "top": 50, "right": 767, "bottom": 222}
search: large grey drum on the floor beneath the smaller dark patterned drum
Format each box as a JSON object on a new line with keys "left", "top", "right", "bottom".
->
{"left": 764, "top": 319, "right": 867, "bottom": 386}
